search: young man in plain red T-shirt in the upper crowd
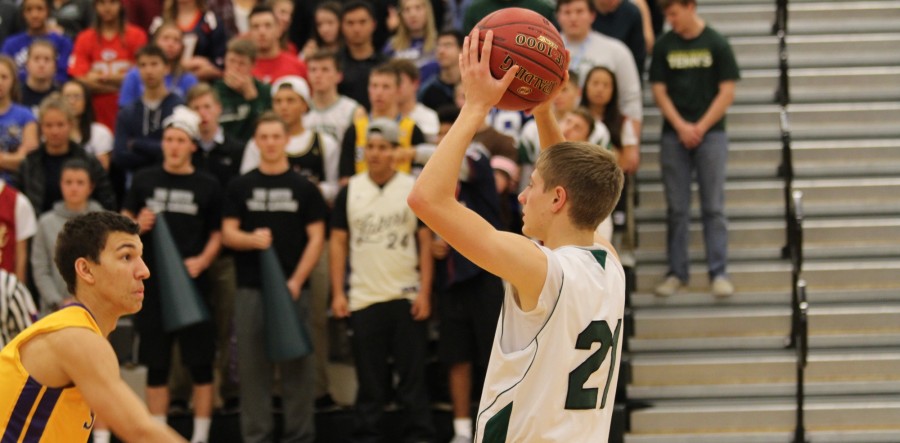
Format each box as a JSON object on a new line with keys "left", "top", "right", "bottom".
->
{"left": 250, "top": 6, "right": 306, "bottom": 84}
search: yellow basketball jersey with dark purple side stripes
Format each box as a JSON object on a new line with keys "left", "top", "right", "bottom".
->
{"left": 0, "top": 305, "right": 102, "bottom": 443}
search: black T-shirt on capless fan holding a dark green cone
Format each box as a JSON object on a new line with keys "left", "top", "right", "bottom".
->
{"left": 225, "top": 169, "right": 327, "bottom": 288}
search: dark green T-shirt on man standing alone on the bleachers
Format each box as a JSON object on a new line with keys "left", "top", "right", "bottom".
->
{"left": 650, "top": 26, "right": 741, "bottom": 131}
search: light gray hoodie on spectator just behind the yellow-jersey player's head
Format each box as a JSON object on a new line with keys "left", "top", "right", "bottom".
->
{"left": 31, "top": 200, "right": 103, "bottom": 315}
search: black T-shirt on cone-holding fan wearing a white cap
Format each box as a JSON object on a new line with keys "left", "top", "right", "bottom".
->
{"left": 123, "top": 166, "right": 222, "bottom": 265}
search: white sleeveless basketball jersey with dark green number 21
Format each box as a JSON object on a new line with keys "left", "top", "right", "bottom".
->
{"left": 475, "top": 245, "right": 625, "bottom": 443}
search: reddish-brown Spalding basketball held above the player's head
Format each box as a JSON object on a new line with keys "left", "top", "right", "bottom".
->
{"left": 475, "top": 8, "right": 569, "bottom": 111}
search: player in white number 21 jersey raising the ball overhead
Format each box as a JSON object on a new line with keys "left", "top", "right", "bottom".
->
{"left": 408, "top": 30, "right": 625, "bottom": 443}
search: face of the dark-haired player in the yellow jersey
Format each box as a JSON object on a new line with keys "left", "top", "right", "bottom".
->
{"left": 88, "top": 232, "right": 150, "bottom": 315}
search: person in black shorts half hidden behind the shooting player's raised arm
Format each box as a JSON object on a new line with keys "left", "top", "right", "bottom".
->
{"left": 432, "top": 108, "right": 512, "bottom": 442}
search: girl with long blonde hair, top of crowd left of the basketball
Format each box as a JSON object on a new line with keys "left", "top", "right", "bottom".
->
{"left": 382, "top": 0, "right": 439, "bottom": 86}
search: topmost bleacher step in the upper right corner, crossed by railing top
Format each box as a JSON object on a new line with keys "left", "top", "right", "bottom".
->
{"left": 698, "top": 0, "right": 900, "bottom": 36}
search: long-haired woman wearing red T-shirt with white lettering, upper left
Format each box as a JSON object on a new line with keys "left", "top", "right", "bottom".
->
{"left": 69, "top": 0, "right": 147, "bottom": 128}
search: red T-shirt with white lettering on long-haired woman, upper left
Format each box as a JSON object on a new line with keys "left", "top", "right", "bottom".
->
{"left": 69, "top": 24, "right": 147, "bottom": 128}
